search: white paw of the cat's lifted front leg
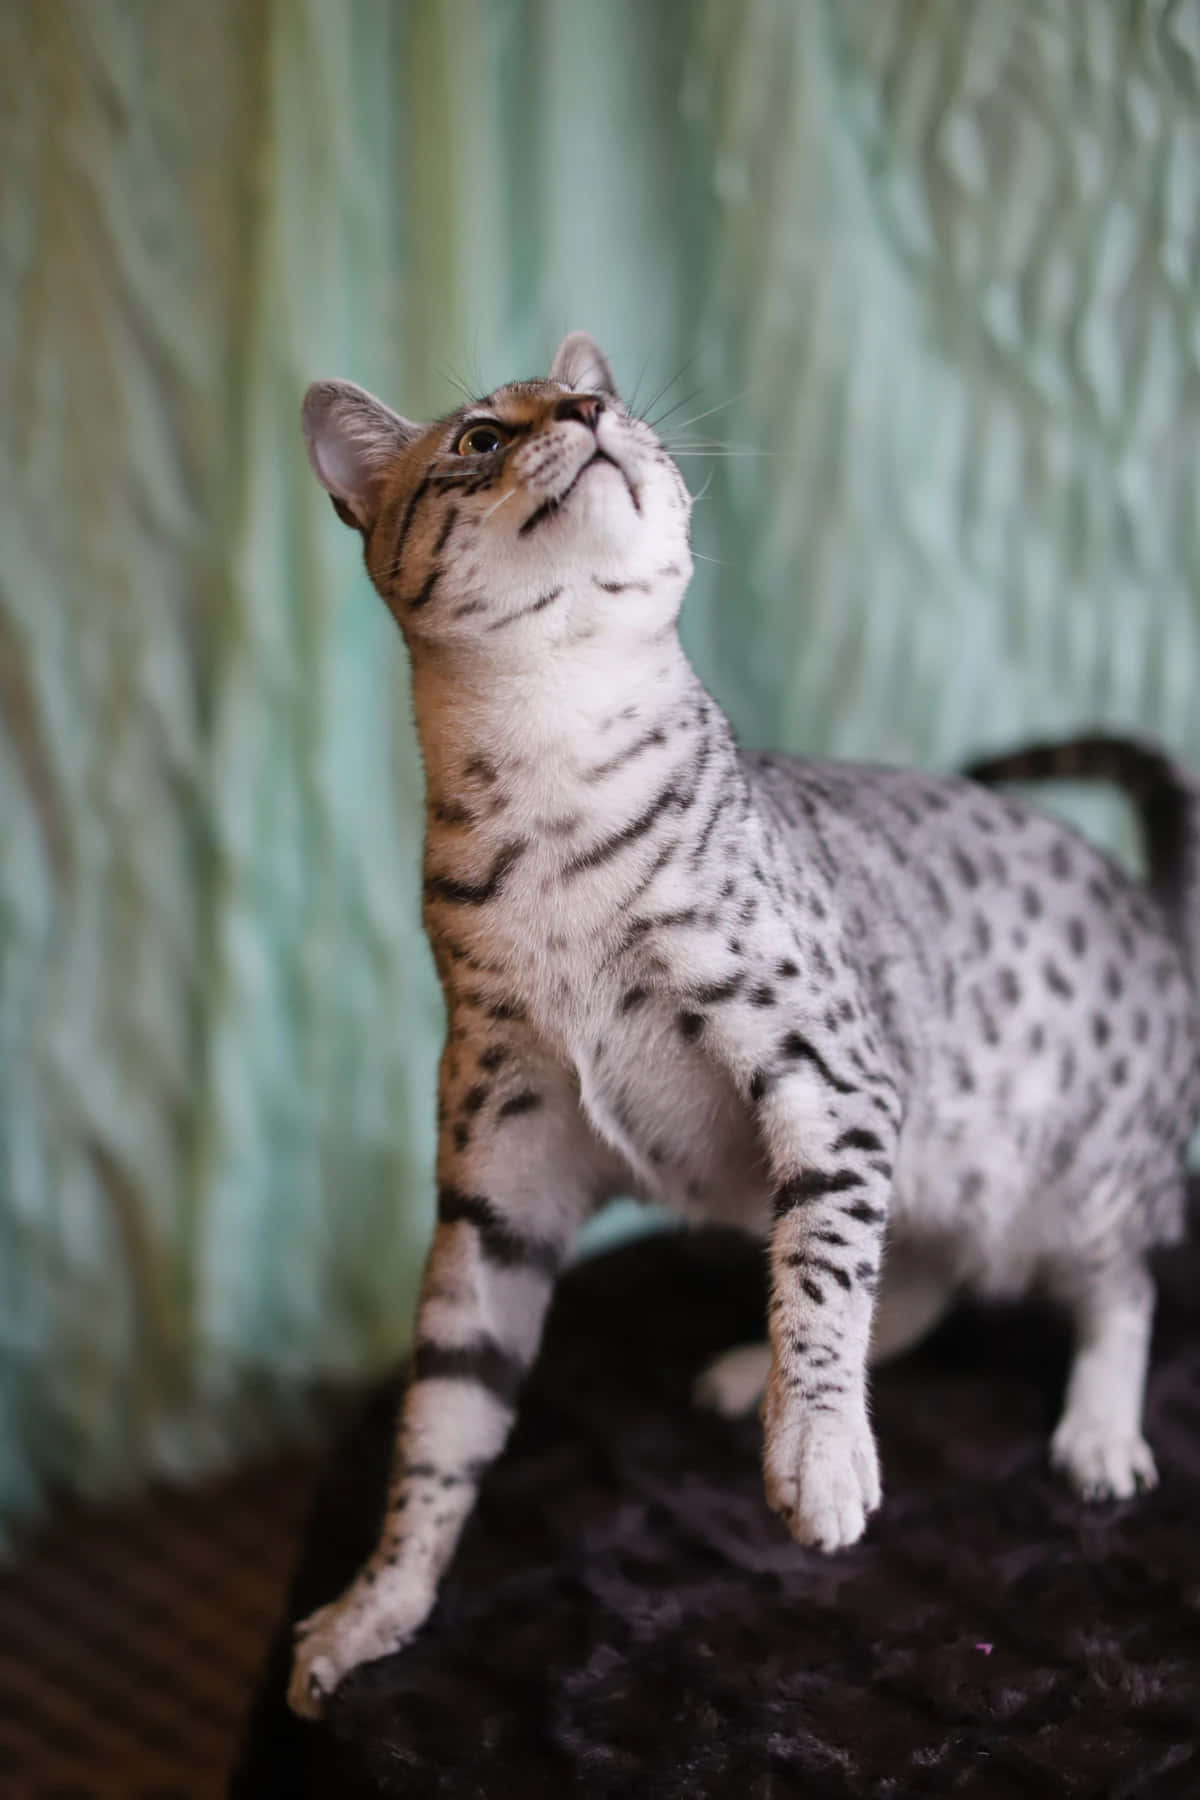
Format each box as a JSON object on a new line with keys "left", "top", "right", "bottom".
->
{"left": 763, "top": 1390, "right": 882, "bottom": 1550}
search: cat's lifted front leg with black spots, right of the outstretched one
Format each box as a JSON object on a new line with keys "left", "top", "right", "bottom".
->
{"left": 759, "top": 1058, "right": 898, "bottom": 1550}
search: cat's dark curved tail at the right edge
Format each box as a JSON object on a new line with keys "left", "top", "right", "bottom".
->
{"left": 964, "top": 733, "right": 1200, "bottom": 992}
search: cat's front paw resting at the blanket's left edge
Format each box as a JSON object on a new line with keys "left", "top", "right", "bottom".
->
{"left": 288, "top": 1570, "right": 434, "bottom": 1719}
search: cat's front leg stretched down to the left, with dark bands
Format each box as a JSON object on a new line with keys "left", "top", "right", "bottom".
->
{"left": 288, "top": 1024, "right": 606, "bottom": 1717}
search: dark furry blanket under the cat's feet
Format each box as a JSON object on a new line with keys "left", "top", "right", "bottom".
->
{"left": 232, "top": 1195, "right": 1200, "bottom": 1800}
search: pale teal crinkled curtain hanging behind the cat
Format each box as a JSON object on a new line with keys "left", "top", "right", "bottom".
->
{"left": 0, "top": 0, "right": 1200, "bottom": 1519}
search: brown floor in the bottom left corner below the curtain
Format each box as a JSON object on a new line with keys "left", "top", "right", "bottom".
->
{"left": 0, "top": 1458, "right": 315, "bottom": 1800}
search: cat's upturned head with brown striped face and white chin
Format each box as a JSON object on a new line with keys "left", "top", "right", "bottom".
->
{"left": 302, "top": 331, "right": 691, "bottom": 655}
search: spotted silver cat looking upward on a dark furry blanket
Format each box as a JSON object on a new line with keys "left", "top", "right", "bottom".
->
{"left": 290, "top": 333, "right": 1200, "bottom": 1715}
